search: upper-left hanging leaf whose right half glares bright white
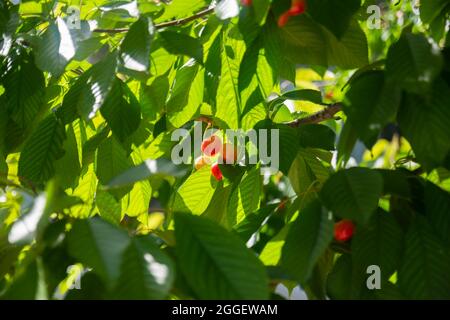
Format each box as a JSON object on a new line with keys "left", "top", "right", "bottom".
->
{"left": 36, "top": 17, "right": 76, "bottom": 77}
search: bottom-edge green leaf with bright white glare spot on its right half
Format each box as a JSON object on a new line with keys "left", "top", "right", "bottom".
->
{"left": 113, "top": 237, "right": 174, "bottom": 300}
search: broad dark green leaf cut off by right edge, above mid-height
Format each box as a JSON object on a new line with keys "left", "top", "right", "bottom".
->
{"left": 398, "top": 79, "right": 450, "bottom": 170}
